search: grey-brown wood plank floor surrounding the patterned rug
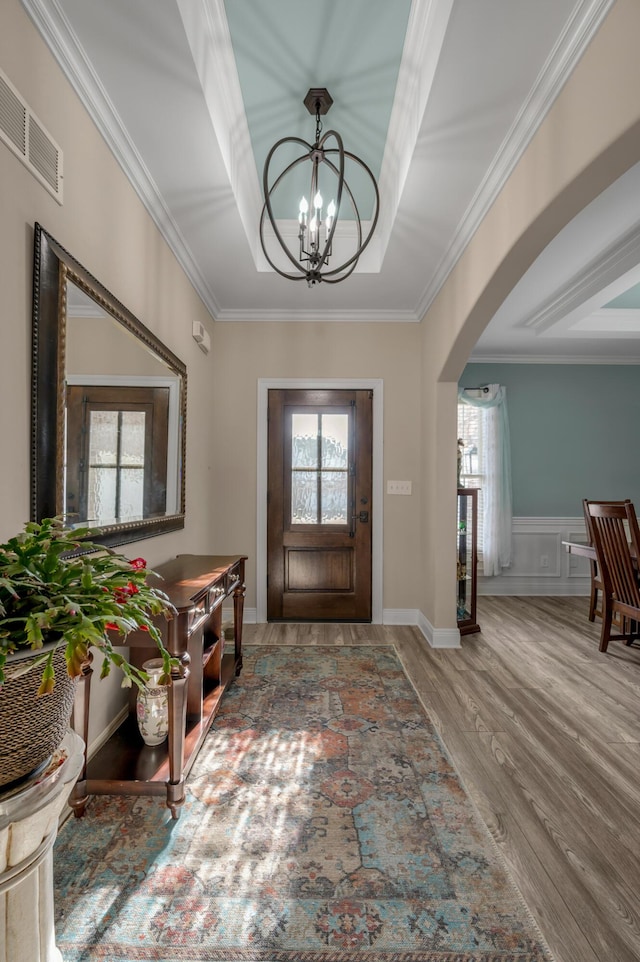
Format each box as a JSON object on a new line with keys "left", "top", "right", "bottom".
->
{"left": 244, "top": 597, "right": 640, "bottom": 962}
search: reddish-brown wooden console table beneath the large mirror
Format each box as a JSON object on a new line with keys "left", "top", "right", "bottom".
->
{"left": 69, "top": 554, "right": 247, "bottom": 818}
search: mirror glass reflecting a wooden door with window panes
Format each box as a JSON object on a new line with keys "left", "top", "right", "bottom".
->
{"left": 64, "top": 283, "right": 181, "bottom": 525}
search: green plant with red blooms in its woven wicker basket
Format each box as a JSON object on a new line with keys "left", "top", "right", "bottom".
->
{"left": 0, "top": 518, "right": 177, "bottom": 786}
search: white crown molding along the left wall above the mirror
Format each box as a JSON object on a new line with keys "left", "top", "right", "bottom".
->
{"left": 21, "top": 0, "right": 219, "bottom": 317}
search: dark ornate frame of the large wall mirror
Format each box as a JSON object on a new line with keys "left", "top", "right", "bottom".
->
{"left": 31, "top": 224, "right": 187, "bottom": 547}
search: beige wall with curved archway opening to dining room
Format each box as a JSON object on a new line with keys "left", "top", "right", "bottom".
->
{"left": 418, "top": 0, "right": 640, "bottom": 627}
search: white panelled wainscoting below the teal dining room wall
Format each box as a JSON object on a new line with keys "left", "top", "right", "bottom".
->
{"left": 478, "top": 517, "right": 590, "bottom": 595}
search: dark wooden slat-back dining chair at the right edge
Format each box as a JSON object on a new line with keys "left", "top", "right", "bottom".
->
{"left": 585, "top": 500, "right": 640, "bottom": 651}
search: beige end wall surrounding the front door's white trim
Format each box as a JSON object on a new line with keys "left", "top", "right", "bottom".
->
{"left": 210, "top": 322, "right": 422, "bottom": 608}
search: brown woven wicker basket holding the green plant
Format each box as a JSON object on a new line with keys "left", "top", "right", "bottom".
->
{"left": 0, "top": 645, "right": 77, "bottom": 791}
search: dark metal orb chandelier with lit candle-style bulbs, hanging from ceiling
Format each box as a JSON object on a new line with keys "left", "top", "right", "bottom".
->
{"left": 260, "top": 87, "right": 380, "bottom": 287}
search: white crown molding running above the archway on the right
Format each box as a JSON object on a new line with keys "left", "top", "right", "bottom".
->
{"left": 416, "top": 0, "right": 615, "bottom": 317}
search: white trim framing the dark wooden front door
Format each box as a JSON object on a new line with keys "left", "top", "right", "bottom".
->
{"left": 256, "top": 378, "right": 384, "bottom": 625}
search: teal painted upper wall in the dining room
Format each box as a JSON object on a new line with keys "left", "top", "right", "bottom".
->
{"left": 460, "top": 364, "right": 640, "bottom": 518}
